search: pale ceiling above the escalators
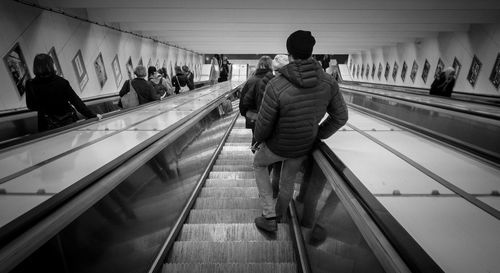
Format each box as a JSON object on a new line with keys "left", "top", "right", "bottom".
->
{"left": 38, "top": 0, "right": 500, "bottom": 54}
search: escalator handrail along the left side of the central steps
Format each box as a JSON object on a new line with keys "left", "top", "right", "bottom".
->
{"left": 0, "top": 87, "right": 239, "bottom": 272}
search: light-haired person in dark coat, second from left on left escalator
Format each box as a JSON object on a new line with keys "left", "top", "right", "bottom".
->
{"left": 119, "top": 65, "right": 162, "bottom": 105}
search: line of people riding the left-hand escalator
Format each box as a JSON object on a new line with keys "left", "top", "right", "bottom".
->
{"left": 26, "top": 54, "right": 195, "bottom": 132}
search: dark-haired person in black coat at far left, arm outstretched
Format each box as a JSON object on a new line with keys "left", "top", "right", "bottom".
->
{"left": 26, "top": 54, "right": 101, "bottom": 132}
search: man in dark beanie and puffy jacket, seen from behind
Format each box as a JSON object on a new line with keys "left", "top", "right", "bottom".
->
{"left": 253, "top": 30, "right": 348, "bottom": 232}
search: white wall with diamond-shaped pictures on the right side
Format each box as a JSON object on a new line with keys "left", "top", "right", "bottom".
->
{"left": 348, "top": 24, "right": 500, "bottom": 96}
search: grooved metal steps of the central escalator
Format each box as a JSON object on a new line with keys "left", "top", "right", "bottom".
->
{"left": 162, "top": 111, "right": 297, "bottom": 273}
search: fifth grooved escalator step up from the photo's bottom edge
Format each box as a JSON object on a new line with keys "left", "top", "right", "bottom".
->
{"left": 194, "top": 197, "right": 261, "bottom": 209}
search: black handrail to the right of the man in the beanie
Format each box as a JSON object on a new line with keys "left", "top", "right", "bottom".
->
{"left": 319, "top": 142, "right": 444, "bottom": 272}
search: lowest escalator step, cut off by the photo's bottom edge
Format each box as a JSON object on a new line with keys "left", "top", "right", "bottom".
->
{"left": 163, "top": 263, "right": 297, "bottom": 273}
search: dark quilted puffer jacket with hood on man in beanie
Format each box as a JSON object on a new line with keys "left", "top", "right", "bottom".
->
{"left": 254, "top": 58, "right": 348, "bottom": 158}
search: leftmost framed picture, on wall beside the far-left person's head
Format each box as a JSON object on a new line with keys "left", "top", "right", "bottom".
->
{"left": 3, "top": 43, "right": 31, "bottom": 97}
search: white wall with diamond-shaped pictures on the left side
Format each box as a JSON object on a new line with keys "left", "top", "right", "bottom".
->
{"left": 0, "top": 1, "right": 204, "bottom": 113}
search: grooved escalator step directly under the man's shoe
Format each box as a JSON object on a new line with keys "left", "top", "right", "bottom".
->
{"left": 177, "top": 223, "right": 292, "bottom": 242}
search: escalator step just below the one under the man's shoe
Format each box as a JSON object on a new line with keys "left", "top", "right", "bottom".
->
{"left": 168, "top": 241, "right": 295, "bottom": 263}
